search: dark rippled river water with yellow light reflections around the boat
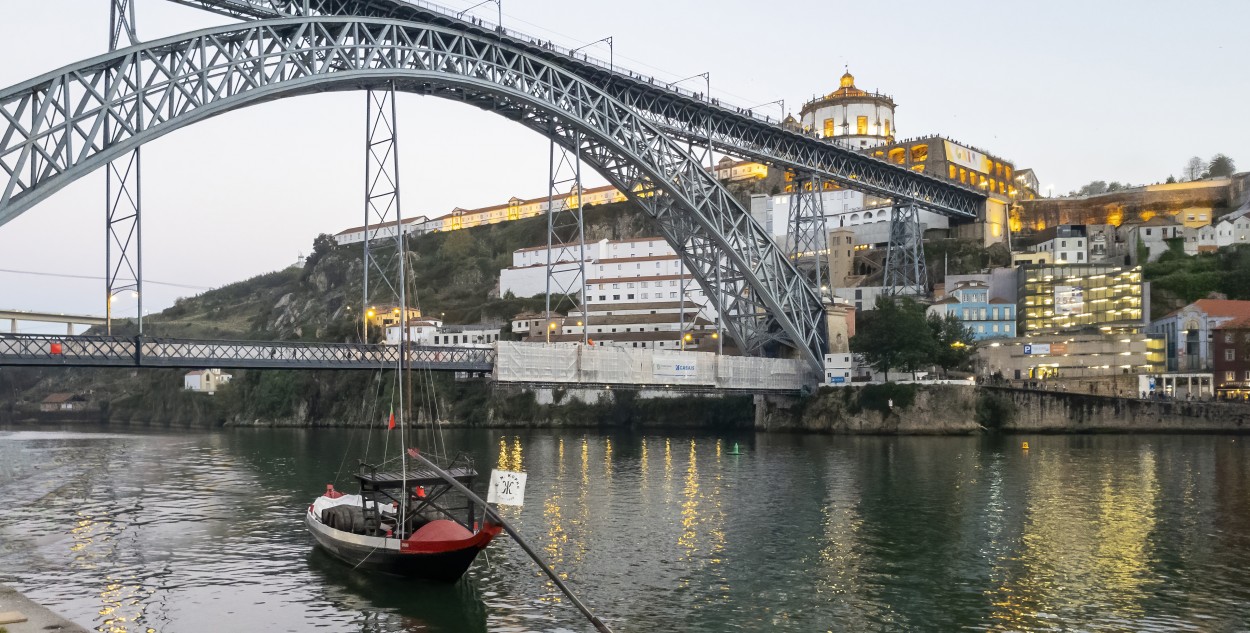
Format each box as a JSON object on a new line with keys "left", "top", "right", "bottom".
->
{"left": 0, "top": 428, "right": 1250, "bottom": 633}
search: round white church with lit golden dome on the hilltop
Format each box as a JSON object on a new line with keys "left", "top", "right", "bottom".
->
{"left": 800, "top": 71, "right": 896, "bottom": 149}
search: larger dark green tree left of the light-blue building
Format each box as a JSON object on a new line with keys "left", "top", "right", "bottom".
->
{"left": 851, "top": 295, "right": 934, "bottom": 380}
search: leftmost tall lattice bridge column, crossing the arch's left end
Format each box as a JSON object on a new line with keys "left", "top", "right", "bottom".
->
{"left": 105, "top": 0, "right": 144, "bottom": 334}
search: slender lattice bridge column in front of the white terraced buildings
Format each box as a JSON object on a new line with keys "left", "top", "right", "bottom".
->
{"left": 544, "top": 129, "right": 587, "bottom": 345}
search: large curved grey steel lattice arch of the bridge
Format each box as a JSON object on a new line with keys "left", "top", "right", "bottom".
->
{"left": 0, "top": 18, "right": 823, "bottom": 367}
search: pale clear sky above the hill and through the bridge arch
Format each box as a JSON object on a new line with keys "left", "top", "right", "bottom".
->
{"left": 0, "top": 0, "right": 1250, "bottom": 322}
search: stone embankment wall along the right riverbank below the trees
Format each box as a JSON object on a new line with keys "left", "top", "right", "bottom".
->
{"left": 755, "top": 384, "right": 1250, "bottom": 434}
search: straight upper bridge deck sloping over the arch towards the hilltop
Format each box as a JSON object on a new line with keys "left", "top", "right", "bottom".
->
{"left": 163, "top": 0, "right": 986, "bottom": 219}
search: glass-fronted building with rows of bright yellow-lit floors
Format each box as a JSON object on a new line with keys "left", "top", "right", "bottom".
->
{"left": 1016, "top": 264, "right": 1149, "bottom": 337}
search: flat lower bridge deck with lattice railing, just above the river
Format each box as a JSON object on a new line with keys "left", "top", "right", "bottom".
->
{"left": 0, "top": 334, "right": 495, "bottom": 372}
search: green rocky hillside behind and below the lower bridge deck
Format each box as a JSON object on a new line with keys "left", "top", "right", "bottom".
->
{"left": 0, "top": 203, "right": 655, "bottom": 425}
